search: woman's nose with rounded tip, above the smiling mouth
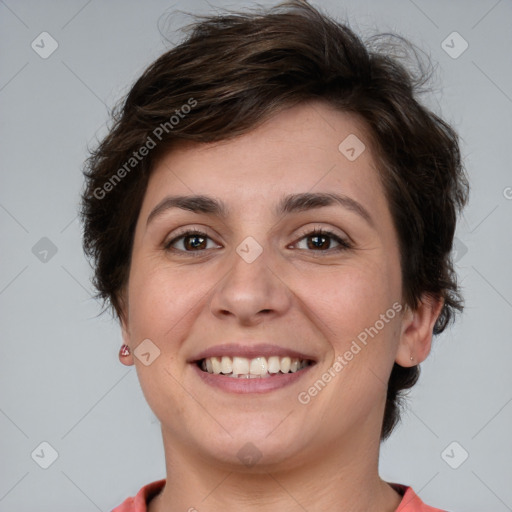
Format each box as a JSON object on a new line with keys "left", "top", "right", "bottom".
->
{"left": 210, "top": 242, "right": 293, "bottom": 326}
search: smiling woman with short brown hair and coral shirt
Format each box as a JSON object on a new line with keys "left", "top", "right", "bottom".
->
{"left": 82, "top": 1, "right": 468, "bottom": 512}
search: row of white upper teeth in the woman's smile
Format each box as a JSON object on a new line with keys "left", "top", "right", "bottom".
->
{"left": 201, "top": 356, "right": 310, "bottom": 378}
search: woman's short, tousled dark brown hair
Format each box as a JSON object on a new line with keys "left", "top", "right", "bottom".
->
{"left": 82, "top": 0, "right": 469, "bottom": 440}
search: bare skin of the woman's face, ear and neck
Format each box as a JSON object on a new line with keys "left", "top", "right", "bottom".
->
{"left": 121, "top": 102, "right": 442, "bottom": 512}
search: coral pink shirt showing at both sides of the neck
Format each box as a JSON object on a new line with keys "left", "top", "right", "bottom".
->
{"left": 111, "top": 478, "right": 446, "bottom": 512}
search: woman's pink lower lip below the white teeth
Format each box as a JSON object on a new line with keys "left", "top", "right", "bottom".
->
{"left": 192, "top": 363, "right": 314, "bottom": 393}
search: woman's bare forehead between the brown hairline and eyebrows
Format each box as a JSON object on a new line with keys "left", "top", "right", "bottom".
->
{"left": 143, "top": 102, "right": 383, "bottom": 215}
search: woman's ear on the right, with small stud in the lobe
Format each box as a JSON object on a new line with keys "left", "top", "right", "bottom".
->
{"left": 395, "top": 294, "right": 444, "bottom": 367}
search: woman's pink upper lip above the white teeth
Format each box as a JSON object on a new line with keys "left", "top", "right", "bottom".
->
{"left": 187, "top": 343, "right": 315, "bottom": 363}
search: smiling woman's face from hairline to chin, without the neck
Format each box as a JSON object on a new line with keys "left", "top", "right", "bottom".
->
{"left": 123, "top": 102, "right": 409, "bottom": 472}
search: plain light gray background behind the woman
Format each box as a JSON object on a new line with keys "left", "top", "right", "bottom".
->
{"left": 0, "top": 0, "right": 512, "bottom": 512}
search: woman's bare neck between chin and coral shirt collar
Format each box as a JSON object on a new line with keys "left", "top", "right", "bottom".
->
{"left": 148, "top": 422, "right": 401, "bottom": 512}
